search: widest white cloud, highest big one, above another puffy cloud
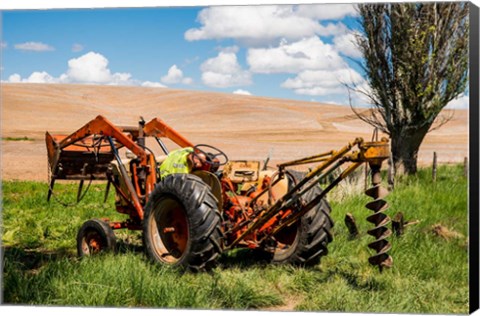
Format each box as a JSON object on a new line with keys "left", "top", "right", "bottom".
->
{"left": 185, "top": 5, "right": 345, "bottom": 44}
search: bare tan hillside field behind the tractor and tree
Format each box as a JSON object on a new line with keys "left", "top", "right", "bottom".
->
{"left": 0, "top": 83, "right": 468, "bottom": 181}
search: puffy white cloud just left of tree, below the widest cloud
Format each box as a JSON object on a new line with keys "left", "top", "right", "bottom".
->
{"left": 247, "top": 36, "right": 344, "bottom": 74}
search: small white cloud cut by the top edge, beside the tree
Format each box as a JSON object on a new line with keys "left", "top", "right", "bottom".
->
{"left": 296, "top": 4, "right": 358, "bottom": 20}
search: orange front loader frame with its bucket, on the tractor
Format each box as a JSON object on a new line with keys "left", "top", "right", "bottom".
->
{"left": 45, "top": 115, "right": 193, "bottom": 229}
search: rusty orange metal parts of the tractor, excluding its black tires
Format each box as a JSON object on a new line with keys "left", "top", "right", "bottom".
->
{"left": 46, "top": 116, "right": 392, "bottom": 269}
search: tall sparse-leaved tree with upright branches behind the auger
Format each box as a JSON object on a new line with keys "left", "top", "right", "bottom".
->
{"left": 350, "top": 2, "right": 469, "bottom": 174}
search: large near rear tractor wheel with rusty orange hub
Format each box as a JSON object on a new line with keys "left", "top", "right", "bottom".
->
{"left": 143, "top": 174, "right": 223, "bottom": 272}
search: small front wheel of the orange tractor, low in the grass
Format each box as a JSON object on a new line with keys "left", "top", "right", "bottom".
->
{"left": 77, "top": 219, "right": 116, "bottom": 257}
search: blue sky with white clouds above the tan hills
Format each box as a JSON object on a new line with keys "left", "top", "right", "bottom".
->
{"left": 1, "top": 4, "right": 468, "bottom": 107}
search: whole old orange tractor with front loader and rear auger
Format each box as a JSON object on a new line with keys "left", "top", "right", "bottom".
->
{"left": 46, "top": 116, "right": 392, "bottom": 271}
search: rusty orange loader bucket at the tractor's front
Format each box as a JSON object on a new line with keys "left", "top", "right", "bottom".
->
{"left": 45, "top": 132, "right": 115, "bottom": 180}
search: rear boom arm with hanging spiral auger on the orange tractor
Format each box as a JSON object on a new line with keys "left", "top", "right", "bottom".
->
{"left": 227, "top": 138, "right": 392, "bottom": 269}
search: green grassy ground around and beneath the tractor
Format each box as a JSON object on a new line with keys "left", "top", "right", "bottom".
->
{"left": 2, "top": 166, "right": 469, "bottom": 314}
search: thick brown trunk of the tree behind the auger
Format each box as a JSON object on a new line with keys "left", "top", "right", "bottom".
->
{"left": 391, "top": 128, "right": 428, "bottom": 174}
